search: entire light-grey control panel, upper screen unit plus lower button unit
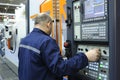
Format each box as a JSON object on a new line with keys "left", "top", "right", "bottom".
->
{"left": 73, "top": 0, "right": 109, "bottom": 80}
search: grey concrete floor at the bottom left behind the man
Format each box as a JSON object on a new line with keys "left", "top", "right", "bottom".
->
{"left": 0, "top": 57, "right": 18, "bottom": 80}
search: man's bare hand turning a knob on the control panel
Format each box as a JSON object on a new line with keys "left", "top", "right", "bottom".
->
{"left": 85, "top": 48, "right": 101, "bottom": 62}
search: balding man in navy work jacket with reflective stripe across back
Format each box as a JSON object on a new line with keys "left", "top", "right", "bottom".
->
{"left": 18, "top": 13, "right": 100, "bottom": 80}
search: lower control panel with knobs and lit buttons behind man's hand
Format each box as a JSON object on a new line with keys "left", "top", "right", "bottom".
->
{"left": 77, "top": 44, "right": 109, "bottom": 80}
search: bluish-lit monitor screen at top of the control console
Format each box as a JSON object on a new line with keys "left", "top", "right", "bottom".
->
{"left": 84, "top": 0, "right": 105, "bottom": 19}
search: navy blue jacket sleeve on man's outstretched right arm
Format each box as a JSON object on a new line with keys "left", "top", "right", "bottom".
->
{"left": 42, "top": 40, "right": 88, "bottom": 76}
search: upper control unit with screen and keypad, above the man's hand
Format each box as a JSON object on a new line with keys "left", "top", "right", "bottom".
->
{"left": 73, "top": 0, "right": 108, "bottom": 42}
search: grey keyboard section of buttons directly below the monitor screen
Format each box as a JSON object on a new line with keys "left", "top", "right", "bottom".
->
{"left": 81, "top": 21, "right": 108, "bottom": 41}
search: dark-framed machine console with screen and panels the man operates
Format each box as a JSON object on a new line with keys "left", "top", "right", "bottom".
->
{"left": 64, "top": 0, "right": 120, "bottom": 80}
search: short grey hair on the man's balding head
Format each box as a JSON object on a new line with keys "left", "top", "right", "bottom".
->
{"left": 34, "top": 13, "right": 52, "bottom": 26}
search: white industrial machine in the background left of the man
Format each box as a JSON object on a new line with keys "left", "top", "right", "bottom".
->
{"left": 3, "top": 4, "right": 27, "bottom": 67}
